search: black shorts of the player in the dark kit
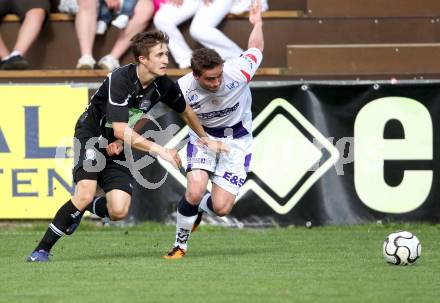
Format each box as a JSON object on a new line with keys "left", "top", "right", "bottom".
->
{"left": 73, "top": 140, "right": 133, "bottom": 195}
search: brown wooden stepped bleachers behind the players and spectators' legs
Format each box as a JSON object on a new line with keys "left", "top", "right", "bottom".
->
{"left": 0, "top": 0, "right": 440, "bottom": 79}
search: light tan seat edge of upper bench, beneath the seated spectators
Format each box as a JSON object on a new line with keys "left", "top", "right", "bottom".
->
{"left": 2, "top": 10, "right": 304, "bottom": 22}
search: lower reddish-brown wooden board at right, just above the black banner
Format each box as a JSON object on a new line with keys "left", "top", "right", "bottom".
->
{"left": 287, "top": 43, "right": 440, "bottom": 76}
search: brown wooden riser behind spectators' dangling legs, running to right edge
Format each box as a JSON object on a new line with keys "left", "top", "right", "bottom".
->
{"left": 0, "top": 17, "right": 440, "bottom": 70}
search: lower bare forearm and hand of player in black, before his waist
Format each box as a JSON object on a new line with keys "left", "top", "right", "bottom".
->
{"left": 113, "top": 122, "right": 182, "bottom": 168}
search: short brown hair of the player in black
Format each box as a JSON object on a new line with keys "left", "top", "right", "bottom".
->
{"left": 130, "top": 30, "right": 170, "bottom": 62}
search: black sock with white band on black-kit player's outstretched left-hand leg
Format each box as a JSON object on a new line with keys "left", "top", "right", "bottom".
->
{"left": 35, "top": 200, "right": 81, "bottom": 251}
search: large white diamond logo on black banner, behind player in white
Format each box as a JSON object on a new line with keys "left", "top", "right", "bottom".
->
{"left": 159, "top": 99, "right": 339, "bottom": 214}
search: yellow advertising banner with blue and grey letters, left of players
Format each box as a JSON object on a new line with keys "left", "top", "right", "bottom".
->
{"left": 0, "top": 85, "right": 88, "bottom": 219}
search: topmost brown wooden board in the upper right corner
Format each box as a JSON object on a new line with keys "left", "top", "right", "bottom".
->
{"left": 307, "top": 0, "right": 440, "bottom": 18}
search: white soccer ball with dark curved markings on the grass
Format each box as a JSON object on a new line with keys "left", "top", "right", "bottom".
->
{"left": 383, "top": 231, "right": 422, "bottom": 265}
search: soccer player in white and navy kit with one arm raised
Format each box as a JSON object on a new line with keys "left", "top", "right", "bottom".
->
{"left": 164, "top": 1, "right": 264, "bottom": 259}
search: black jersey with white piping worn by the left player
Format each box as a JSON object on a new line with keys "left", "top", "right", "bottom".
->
{"left": 75, "top": 64, "right": 186, "bottom": 143}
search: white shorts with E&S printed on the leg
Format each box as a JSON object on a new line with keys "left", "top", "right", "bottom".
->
{"left": 187, "top": 135, "right": 253, "bottom": 195}
